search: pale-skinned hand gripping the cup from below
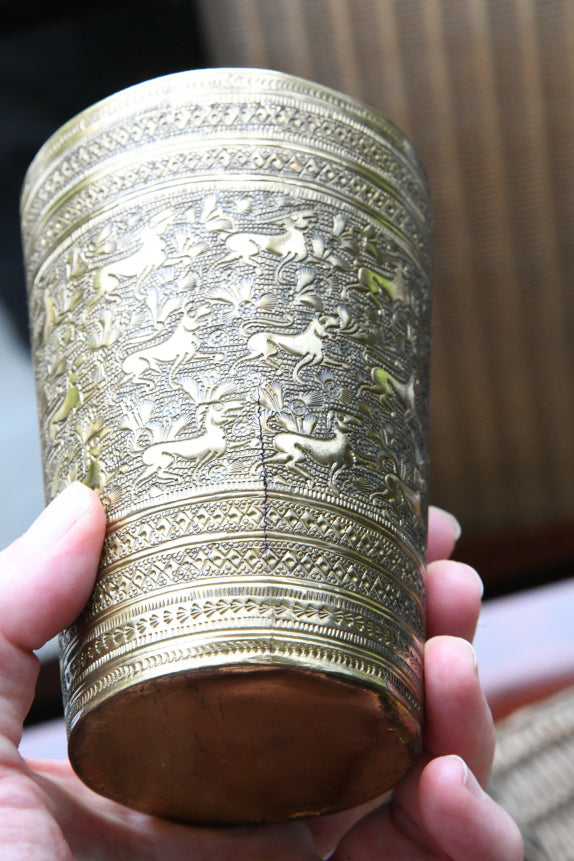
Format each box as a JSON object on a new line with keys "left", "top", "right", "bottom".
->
{"left": 0, "top": 484, "right": 523, "bottom": 861}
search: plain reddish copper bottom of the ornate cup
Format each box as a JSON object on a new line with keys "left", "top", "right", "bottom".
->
{"left": 69, "top": 666, "right": 420, "bottom": 825}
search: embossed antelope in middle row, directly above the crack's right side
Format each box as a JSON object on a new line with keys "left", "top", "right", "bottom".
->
{"left": 238, "top": 314, "right": 346, "bottom": 384}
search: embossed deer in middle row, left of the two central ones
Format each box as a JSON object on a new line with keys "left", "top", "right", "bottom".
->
{"left": 122, "top": 304, "right": 214, "bottom": 388}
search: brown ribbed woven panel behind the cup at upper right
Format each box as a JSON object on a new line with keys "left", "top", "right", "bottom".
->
{"left": 199, "top": 0, "right": 574, "bottom": 533}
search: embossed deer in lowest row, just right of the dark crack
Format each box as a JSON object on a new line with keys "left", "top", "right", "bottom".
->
{"left": 269, "top": 410, "right": 358, "bottom": 484}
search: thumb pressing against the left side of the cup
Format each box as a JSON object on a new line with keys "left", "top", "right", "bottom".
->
{"left": 0, "top": 483, "right": 105, "bottom": 745}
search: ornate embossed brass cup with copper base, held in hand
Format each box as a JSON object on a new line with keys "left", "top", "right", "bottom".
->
{"left": 22, "top": 70, "right": 430, "bottom": 823}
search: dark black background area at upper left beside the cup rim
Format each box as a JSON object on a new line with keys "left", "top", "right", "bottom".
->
{"left": 0, "top": 0, "right": 212, "bottom": 344}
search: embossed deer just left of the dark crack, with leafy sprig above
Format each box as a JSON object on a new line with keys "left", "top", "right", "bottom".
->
{"left": 136, "top": 381, "right": 244, "bottom": 486}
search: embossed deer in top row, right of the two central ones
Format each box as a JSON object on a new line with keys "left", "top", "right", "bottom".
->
{"left": 216, "top": 209, "right": 315, "bottom": 280}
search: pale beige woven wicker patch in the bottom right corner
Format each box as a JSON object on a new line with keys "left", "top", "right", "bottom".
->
{"left": 490, "top": 690, "right": 574, "bottom": 861}
